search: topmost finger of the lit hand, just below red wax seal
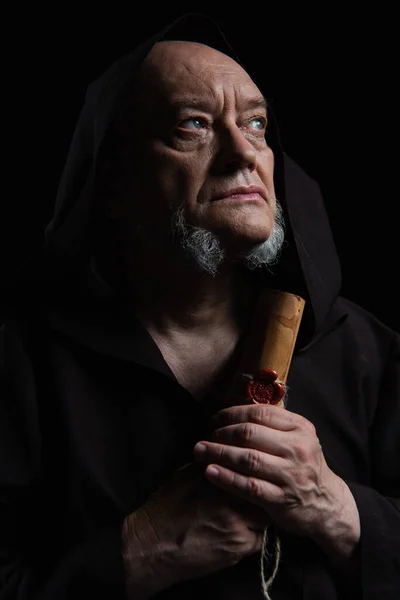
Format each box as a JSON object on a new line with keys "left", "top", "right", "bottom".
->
{"left": 211, "top": 404, "right": 306, "bottom": 431}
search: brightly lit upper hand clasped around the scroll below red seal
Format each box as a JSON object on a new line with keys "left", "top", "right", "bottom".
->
{"left": 195, "top": 404, "right": 360, "bottom": 560}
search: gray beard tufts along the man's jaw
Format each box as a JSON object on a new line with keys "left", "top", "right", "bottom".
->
{"left": 172, "top": 201, "right": 285, "bottom": 277}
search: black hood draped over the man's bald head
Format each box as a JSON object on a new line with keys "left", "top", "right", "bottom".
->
{"left": 3, "top": 15, "right": 341, "bottom": 342}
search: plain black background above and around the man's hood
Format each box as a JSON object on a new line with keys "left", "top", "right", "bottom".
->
{"left": 0, "top": 3, "right": 400, "bottom": 330}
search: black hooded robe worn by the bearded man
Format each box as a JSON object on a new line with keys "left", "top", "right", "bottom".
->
{"left": 0, "top": 11, "right": 400, "bottom": 600}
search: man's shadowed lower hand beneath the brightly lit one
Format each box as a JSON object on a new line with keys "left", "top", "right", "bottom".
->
{"left": 123, "top": 464, "right": 268, "bottom": 600}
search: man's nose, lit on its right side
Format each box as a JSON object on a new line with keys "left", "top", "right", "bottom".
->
{"left": 214, "top": 124, "right": 257, "bottom": 172}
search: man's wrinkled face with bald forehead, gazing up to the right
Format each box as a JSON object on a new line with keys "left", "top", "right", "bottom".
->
{"left": 112, "top": 42, "right": 276, "bottom": 252}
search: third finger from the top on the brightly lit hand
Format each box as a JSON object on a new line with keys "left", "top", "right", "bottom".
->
{"left": 194, "top": 442, "right": 287, "bottom": 485}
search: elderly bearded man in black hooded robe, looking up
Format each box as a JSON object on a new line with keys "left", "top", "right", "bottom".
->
{"left": 0, "top": 12, "right": 400, "bottom": 600}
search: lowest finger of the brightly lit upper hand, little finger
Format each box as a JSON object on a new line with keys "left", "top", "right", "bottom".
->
{"left": 205, "top": 464, "right": 284, "bottom": 510}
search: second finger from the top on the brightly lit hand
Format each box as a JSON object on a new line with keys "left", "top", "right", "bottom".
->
{"left": 210, "top": 422, "right": 293, "bottom": 457}
